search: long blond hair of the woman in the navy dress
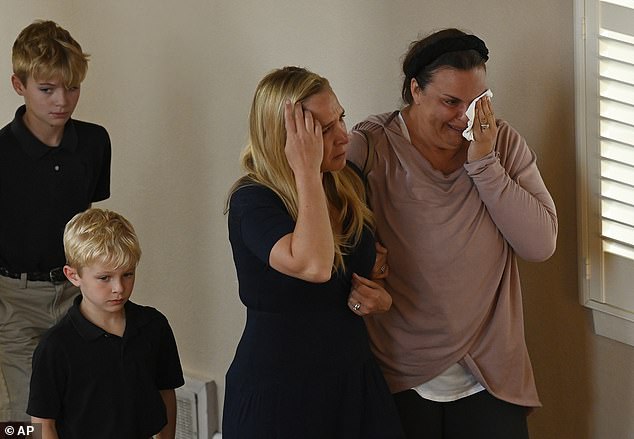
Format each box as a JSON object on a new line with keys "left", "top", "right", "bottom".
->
{"left": 230, "top": 67, "right": 374, "bottom": 269}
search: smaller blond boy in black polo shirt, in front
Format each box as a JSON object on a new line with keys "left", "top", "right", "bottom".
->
{"left": 27, "top": 209, "right": 184, "bottom": 439}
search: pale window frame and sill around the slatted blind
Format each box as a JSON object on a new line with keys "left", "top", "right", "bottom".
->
{"left": 574, "top": 0, "right": 634, "bottom": 346}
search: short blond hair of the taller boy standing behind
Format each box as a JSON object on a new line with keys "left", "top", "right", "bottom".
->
{"left": 11, "top": 20, "right": 89, "bottom": 88}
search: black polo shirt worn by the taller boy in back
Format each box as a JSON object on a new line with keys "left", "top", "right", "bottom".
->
{"left": 0, "top": 106, "right": 111, "bottom": 273}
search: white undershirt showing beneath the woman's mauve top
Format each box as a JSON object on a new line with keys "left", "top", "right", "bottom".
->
{"left": 398, "top": 112, "right": 484, "bottom": 402}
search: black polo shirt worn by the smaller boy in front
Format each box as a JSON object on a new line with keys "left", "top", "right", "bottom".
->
{"left": 27, "top": 296, "right": 184, "bottom": 439}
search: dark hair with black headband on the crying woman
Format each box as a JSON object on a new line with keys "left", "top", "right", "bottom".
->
{"left": 401, "top": 29, "right": 489, "bottom": 104}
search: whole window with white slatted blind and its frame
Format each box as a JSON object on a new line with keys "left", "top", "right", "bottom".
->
{"left": 575, "top": 0, "right": 634, "bottom": 346}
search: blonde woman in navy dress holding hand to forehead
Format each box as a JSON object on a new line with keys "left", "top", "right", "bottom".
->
{"left": 223, "top": 67, "right": 401, "bottom": 439}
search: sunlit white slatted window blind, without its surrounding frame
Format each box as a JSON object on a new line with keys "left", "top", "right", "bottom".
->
{"left": 598, "top": 0, "right": 634, "bottom": 261}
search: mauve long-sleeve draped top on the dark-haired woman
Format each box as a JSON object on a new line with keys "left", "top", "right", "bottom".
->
{"left": 348, "top": 113, "right": 557, "bottom": 407}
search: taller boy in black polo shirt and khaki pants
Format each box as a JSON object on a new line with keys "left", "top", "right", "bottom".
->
{"left": 0, "top": 21, "right": 110, "bottom": 422}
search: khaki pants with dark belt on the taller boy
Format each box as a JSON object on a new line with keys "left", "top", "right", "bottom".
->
{"left": 0, "top": 275, "right": 79, "bottom": 422}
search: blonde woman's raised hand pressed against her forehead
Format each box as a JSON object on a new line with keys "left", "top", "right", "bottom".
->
{"left": 284, "top": 101, "right": 324, "bottom": 176}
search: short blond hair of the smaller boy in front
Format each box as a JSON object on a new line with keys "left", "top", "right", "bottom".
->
{"left": 64, "top": 208, "right": 141, "bottom": 273}
